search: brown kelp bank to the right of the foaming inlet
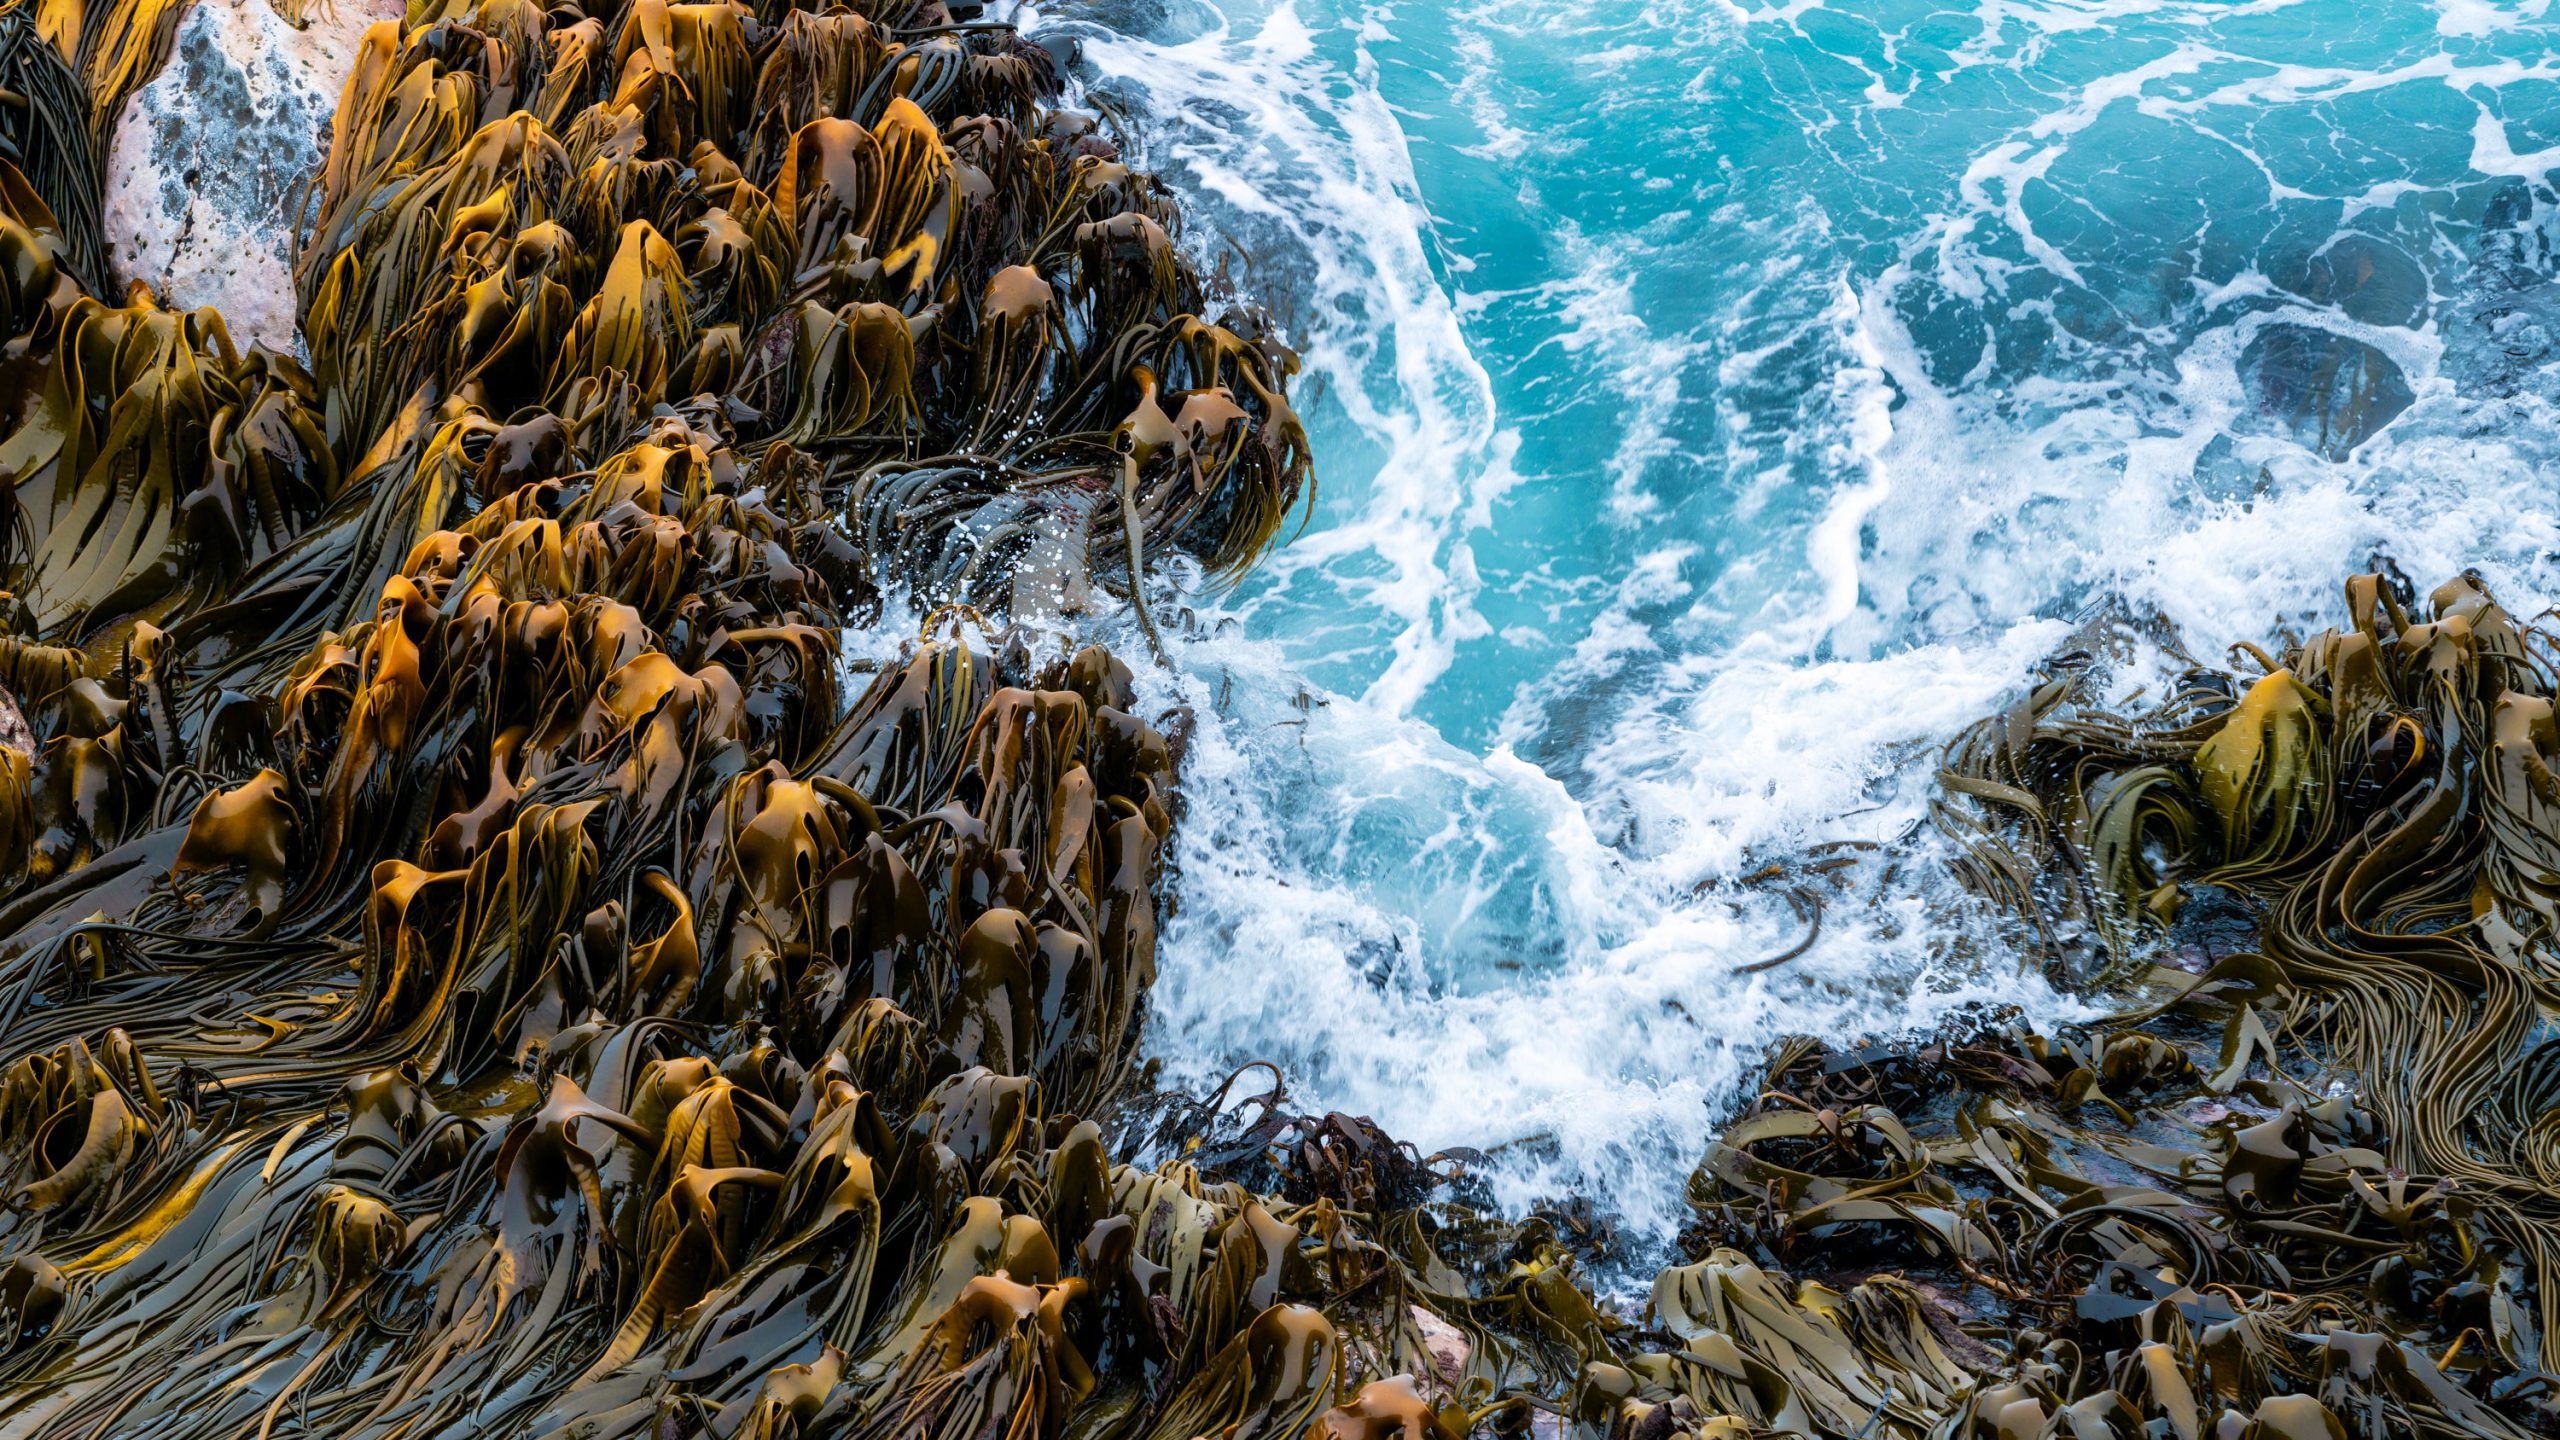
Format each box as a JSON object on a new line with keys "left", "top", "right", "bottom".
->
{"left": 1648, "top": 574, "right": 2560, "bottom": 1435}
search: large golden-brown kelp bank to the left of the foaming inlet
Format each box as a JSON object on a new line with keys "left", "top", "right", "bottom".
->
{"left": 0, "top": 0, "right": 1610, "bottom": 1440}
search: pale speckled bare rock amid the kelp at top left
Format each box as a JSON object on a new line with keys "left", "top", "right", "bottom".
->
{"left": 105, "top": 0, "right": 402, "bottom": 354}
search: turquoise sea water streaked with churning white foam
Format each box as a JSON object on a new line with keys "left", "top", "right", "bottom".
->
{"left": 1027, "top": 0, "right": 2560, "bottom": 1232}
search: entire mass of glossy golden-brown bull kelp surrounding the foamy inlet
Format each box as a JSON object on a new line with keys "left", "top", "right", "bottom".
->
{"left": 0, "top": 0, "right": 2560, "bottom": 1440}
